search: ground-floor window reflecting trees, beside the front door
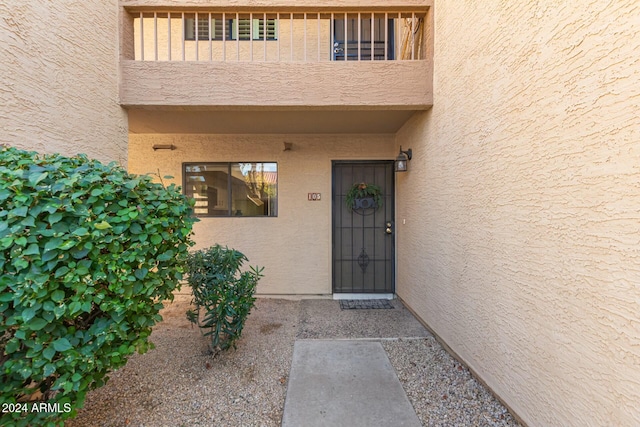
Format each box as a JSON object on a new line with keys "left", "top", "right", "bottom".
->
{"left": 183, "top": 162, "right": 278, "bottom": 216}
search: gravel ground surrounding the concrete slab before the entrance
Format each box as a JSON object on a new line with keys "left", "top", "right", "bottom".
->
{"left": 65, "top": 295, "right": 519, "bottom": 427}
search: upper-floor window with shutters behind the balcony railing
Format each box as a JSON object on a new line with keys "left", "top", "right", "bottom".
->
{"left": 184, "top": 15, "right": 278, "bottom": 40}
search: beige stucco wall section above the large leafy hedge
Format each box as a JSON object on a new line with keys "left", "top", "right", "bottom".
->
{"left": 0, "top": 0, "right": 127, "bottom": 163}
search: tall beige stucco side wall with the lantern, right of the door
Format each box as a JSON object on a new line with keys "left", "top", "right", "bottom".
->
{"left": 396, "top": 0, "right": 640, "bottom": 426}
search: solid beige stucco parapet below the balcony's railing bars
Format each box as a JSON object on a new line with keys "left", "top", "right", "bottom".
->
{"left": 121, "top": 60, "right": 432, "bottom": 109}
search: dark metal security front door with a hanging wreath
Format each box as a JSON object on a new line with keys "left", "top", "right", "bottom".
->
{"left": 332, "top": 161, "right": 395, "bottom": 293}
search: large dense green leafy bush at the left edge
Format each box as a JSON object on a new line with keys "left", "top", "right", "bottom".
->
{"left": 0, "top": 147, "right": 194, "bottom": 425}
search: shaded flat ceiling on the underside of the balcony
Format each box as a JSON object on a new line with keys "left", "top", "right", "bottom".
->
{"left": 128, "top": 109, "right": 415, "bottom": 134}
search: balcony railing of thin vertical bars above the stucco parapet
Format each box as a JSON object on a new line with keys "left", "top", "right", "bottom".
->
{"left": 129, "top": 11, "right": 427, "bottom": 62}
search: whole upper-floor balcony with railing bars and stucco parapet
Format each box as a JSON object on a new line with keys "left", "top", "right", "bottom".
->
{"left": 120, "top": 1, "right": 433, "bottom": 131}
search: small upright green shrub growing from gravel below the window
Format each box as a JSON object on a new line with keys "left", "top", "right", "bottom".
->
{"left": 187, "top": 245, "right": 264, "bottom": 352}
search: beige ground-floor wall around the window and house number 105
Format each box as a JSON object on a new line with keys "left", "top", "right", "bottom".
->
{"left": 129, "top": 134, "right": 396, "bottom": 296}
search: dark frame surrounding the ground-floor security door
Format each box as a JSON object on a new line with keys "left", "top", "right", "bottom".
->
{"left": 331, "top": 159, "right": 397, "bottom": 299}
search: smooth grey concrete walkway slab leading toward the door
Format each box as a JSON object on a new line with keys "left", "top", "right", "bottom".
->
{"left": 282, "top": 340, "right": 421, "bottom": 427}
